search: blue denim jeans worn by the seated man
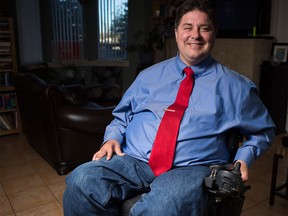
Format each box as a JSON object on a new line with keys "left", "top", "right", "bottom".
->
{"left": 63, "top": 155, "right": 210, "bottom": 216}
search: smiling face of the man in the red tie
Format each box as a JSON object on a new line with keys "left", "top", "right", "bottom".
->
{"left": 175, "top": 10, "right": 216, "bottom": 66}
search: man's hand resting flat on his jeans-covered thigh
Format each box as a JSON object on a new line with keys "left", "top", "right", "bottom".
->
{"left": 92, "top": 140, "right": 125, "bottom": 160}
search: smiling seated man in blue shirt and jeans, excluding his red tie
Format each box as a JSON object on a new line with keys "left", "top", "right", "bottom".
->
{"left": 64, "top": 0, "right": 274, "bottom": 216}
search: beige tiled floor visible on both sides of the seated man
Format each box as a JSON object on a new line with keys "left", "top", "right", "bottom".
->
{"left": 0, "top": 134, "right": 288, "bottom": 216}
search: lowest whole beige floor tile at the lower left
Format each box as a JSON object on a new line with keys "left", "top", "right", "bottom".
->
{"left": 9, "top": 187, "right": 55, "bottom": 211}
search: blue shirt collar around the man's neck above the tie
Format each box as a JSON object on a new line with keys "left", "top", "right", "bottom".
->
{"left": 176, "top": 52, "right": 214, "bottom": 77}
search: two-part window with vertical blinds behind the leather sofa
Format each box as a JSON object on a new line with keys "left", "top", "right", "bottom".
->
{"left": 51, "top": 0, "right": 128, "bottom": 61}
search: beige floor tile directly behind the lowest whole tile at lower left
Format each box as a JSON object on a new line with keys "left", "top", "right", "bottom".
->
{"left": 3, "top": 174, "right": 45, "bottom": 195}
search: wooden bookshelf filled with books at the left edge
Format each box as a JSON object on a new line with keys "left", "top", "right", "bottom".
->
{"left": 0, "top": 16, "right": 20, "bottom": 136}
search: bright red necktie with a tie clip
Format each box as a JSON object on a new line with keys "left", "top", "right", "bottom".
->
{"left": 149, "top": 67, "right": 194, "bottom": 176}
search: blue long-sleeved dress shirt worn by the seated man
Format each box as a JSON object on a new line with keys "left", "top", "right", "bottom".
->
{"left": 104, "top": 55, "right": 275, "bottom": 166}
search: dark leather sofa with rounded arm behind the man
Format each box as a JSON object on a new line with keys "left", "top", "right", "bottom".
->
{"left": 12, "top": 72, "right": 115, "bottom": 175}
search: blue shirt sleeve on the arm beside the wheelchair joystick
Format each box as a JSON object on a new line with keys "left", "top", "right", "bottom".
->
{"left": 235, "top": 83, "right": 275, "bottom": 167}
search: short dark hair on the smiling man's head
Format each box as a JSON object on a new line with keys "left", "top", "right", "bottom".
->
{"left": 174, "top": 0, "right": 216, "bottom": 29}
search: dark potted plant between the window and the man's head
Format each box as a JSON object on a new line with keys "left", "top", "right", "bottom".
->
{"left": 126, "top": 29, "right": 164, "bottom": 65}
